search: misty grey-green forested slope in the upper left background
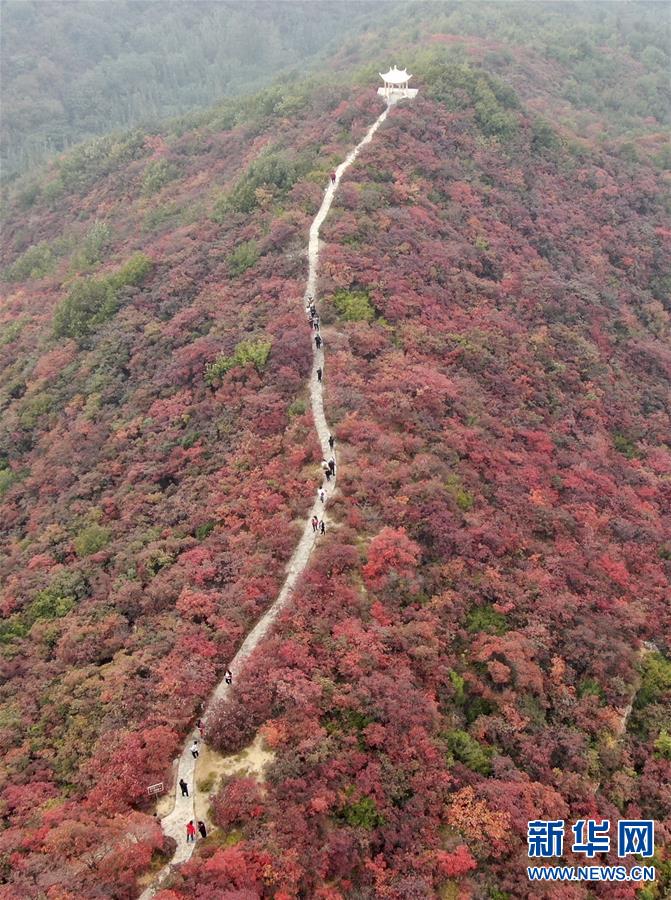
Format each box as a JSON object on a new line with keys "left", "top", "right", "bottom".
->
{"left": 0, "top": 0, "right": 384, "bottom": 174}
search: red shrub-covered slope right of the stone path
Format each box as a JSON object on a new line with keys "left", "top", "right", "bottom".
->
{"left": 197, "top": 67, "right": 671, "bottom": 898}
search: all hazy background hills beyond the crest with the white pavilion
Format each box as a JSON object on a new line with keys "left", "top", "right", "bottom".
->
{"left": 0, "top": 0, "right": 671, "bottom": 175}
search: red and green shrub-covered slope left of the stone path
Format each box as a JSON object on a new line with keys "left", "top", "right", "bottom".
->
{"left": 0, "top": 81, "right": 386, "bottom": 896}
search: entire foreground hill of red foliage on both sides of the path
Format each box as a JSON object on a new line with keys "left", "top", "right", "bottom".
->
{"left": 0, "top": 14, "right": 671, "bottom": 900}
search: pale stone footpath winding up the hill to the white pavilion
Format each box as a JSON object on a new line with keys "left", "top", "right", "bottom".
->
{"left": 140, "top": 106, "right": 391, "bottom": 900}
